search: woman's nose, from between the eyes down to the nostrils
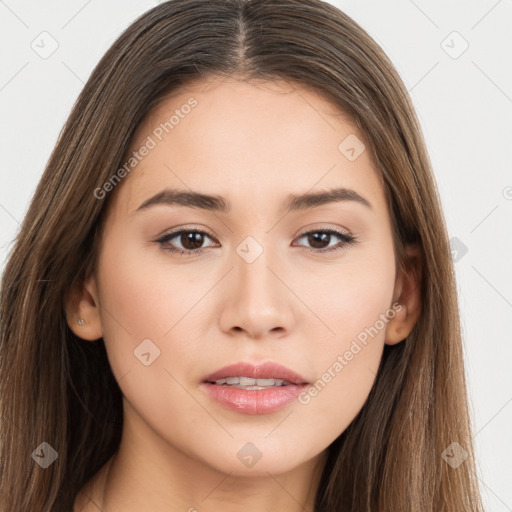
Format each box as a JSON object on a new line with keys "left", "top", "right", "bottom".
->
{"left": 220, "top": 244, "right": 294, "bottom": 339}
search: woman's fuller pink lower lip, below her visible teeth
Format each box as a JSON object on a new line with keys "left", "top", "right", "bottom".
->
{"left": 201, "top": 382, "right": 308, "bottom": 414}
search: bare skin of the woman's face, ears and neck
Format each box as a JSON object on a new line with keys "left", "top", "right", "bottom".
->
{"left": 67, "top": 78, "right": 419, "bottom": 512}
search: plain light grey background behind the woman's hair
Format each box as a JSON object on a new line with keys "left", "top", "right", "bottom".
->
{"left": 0, "top": 0, "right": 512, "bottom": 512}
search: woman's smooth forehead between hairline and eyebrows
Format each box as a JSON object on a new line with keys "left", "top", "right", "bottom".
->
{"left": 110, "top": 78, "right": 384, "bottom": 217}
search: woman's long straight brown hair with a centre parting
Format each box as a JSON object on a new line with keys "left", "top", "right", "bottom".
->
{"left": 0, "top": 0, "right": 482, "bottom": 512}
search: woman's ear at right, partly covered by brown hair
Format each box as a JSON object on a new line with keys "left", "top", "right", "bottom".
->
{"left": 385, "top": 244, "right": 422, "bottom": 345}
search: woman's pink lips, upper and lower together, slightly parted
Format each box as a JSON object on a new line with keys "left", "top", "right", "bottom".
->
{"left": 200, "top": 362, "right": 308, "bottom": 414}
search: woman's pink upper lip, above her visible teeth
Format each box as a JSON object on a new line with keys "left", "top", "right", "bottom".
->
{"left": 204, "top": 361, "right": 308, "bottom": 384}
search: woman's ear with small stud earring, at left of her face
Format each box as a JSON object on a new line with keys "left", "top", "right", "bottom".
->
{"left": 65, "top": 276, "right": 103, "bottom": 341}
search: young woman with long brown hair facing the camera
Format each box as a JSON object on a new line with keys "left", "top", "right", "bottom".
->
{"left": 0, "top": 0, "right": 482, "bottom": 512}
